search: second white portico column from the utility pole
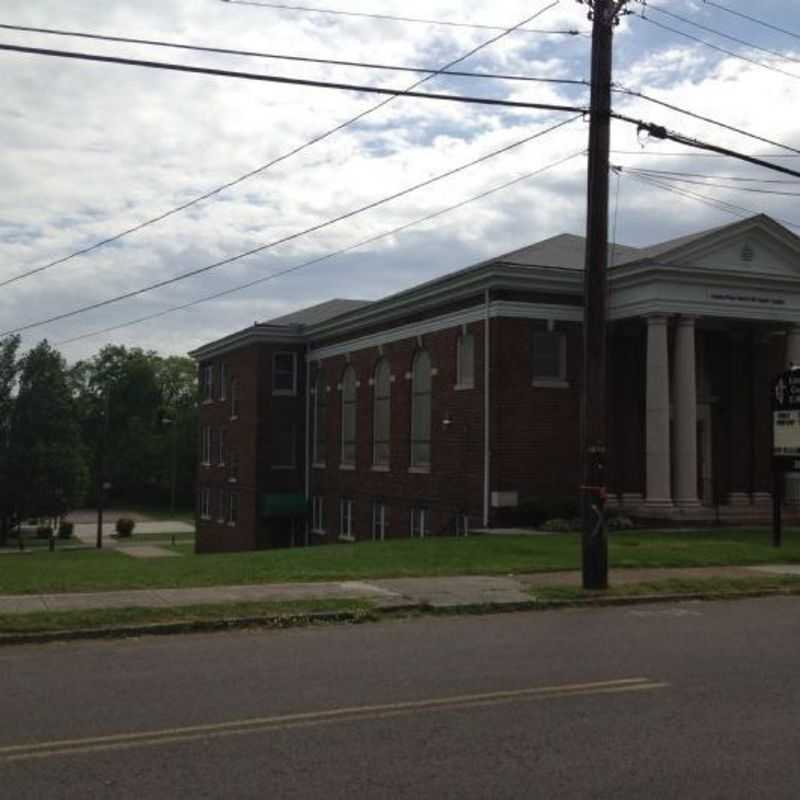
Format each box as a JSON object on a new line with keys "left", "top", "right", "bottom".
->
{"left": 674, "top": 317, "right": 701, "bottom": 511}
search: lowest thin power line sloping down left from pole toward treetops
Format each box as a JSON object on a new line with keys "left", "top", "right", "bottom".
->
{"left": 56, "top": 150, "right": 586, "bottom": 346}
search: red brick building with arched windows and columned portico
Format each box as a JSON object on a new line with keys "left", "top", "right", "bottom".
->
{"left": 192, "top": 215, "right": 800, "bottom": 551}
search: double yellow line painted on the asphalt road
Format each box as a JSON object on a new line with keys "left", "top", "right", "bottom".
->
{"left": 0, "top": 678, "right": 668, "bottom": 763}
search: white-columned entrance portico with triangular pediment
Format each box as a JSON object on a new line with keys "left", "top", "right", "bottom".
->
{"left": 609, "top": 217, "right": 800, "bottom": 520}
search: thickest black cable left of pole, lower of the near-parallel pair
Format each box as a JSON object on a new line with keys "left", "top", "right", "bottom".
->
{"left": 0, "top": 44, "right": 580, "bottom": 111}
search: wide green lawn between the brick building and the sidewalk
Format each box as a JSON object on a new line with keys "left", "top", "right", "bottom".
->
{"left": 0, "top": 529, "right": 800, "bottom": 594}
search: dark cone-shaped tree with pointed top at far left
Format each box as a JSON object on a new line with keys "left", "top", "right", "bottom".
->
{"left": 9, "top": 340, "right": 86, "bottom": 518}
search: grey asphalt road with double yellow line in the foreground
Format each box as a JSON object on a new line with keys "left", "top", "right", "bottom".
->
{"left": 0, "top": 598, "right": 800, "bottom": 800}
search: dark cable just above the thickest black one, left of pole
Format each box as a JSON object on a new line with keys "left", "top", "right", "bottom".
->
{"left": 0, "top": 23, "right": 589, "bottom": 86}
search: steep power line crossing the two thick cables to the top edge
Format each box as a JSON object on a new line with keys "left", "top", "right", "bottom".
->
{"left": 0, "top": 0, "right": 558, "bottom": 286}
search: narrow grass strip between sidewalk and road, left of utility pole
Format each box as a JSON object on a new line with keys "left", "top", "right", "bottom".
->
{"left": 0, "top": 599, "right": 372, "bottom": 635}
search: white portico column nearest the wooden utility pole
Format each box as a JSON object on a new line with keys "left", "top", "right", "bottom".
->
{"left": 643, "top": 314, "right": 674, "bottom": 513}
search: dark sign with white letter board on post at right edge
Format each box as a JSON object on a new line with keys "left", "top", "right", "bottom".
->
{"left": 772, "top": 367, "right": 800, "bottom": 547}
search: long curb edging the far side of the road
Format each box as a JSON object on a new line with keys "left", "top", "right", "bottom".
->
{"left": 0, "top": 587, "right": 800, "bottom": 648}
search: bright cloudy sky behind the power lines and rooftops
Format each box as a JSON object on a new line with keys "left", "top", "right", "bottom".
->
{"left": 0, "top": 0, "right": 800, "bottom": 362}
